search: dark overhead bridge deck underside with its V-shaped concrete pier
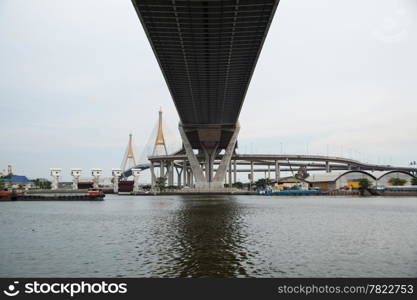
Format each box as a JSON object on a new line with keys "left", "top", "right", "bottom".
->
{"left": 132, "top": 0, "right": 279, "bottom": 188}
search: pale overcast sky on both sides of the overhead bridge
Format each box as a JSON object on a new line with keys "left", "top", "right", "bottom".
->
{"left": 0, "top": 0, "right": 417, "bottom": 178}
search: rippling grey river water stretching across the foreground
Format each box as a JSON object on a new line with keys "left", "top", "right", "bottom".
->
{"left": 0, "top": 195, "right": 417, "bottom": 277}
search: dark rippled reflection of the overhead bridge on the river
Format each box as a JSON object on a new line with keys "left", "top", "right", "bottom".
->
{"left": 172, "top": 196, "right": 250, "bottom": 277}
